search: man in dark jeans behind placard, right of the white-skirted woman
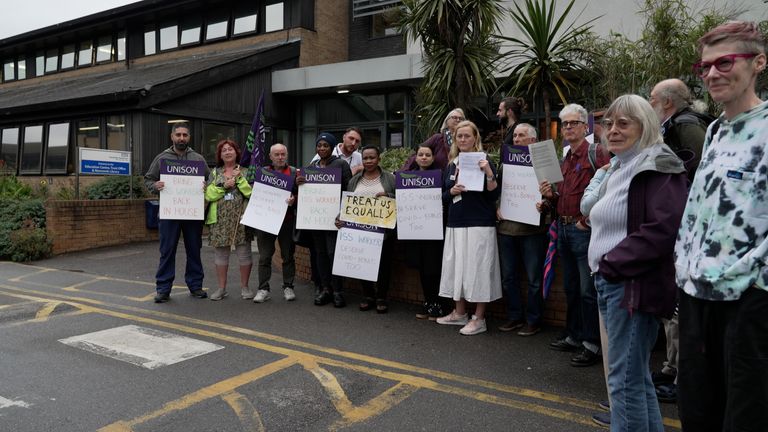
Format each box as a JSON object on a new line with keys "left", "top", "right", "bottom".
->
{"left": 496, "top": 123, "right": 551, "bottom": 336}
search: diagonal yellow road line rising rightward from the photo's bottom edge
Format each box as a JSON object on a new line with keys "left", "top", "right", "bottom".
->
{"left": 99, "top": 357, "right": 296, "bottom": 432}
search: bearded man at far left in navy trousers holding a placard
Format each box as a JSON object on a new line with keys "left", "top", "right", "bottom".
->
{"left": 144, "top": 123, "right": 208, "bottom": 303}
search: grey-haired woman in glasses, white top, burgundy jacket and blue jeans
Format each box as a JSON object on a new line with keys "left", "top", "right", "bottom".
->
{"left": 588, "top": 95, "right": 687, "bottom": 432}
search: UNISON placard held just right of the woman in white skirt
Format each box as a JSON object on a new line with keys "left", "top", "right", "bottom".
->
{"left": 499, "top": 146, "right": 541, "bottom": 226}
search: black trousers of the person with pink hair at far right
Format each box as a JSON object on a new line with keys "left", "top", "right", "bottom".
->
{"left": 677, "top": 287, "right": 768, "bottom": 432}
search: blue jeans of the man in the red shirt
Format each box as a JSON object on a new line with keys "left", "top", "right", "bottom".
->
{"left": 557, "top": 222, "right": 600, "bottom": 346}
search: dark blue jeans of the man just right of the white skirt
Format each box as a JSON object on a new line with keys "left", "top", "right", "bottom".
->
{"left": 498, "top": 233, "right": 547, "bottom": 325}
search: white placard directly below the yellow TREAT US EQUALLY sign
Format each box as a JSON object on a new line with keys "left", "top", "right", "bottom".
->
{"left": 332, "top": 222, "right": 389, "bottom": 282}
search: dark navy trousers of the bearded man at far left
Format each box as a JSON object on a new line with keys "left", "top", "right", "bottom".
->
{"left": 155, "top": 219, "right": 203, "bottom": 294}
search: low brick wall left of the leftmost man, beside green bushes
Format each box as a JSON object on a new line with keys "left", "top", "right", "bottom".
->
{"left": 45, "top": 200, "right": 158, "bottom": 254}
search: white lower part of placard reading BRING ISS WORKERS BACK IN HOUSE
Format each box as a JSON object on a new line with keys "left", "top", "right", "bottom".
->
{"left": 159, "top": 174, "right": 205, "bottom": 220}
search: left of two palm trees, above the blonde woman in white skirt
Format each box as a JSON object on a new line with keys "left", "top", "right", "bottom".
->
{"left": 398, "top": 0, "right": 504, "bottom": 137}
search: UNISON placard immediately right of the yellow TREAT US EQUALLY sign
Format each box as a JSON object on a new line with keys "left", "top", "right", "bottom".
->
{"left": 395, "top": 170, "right": 443, "bottom": 240}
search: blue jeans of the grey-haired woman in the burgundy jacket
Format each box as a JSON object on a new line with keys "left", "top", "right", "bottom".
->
{"left": 595, "top": 275, "right": 664, "bottom": 432}
